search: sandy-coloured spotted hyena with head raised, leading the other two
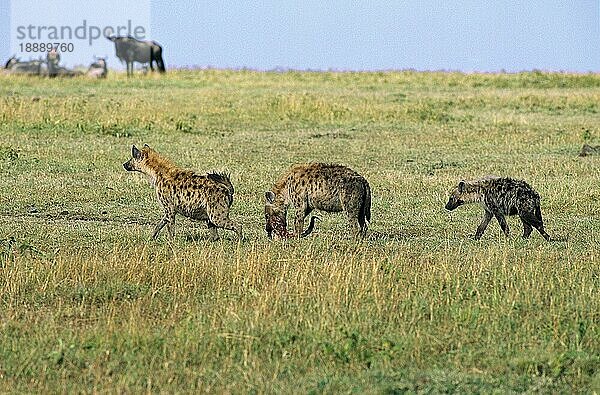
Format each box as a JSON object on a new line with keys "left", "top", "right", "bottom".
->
{"left": 123, "top": 144, "right": 242, "bottom": 240}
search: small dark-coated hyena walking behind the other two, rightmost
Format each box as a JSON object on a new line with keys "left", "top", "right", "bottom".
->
{"left": 446, "top": 176, "right": 550, "bottom": 241}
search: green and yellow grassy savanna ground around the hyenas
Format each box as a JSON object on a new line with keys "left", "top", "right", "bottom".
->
{"left": 0, "top": 70, "right": 600, "bottom": 393}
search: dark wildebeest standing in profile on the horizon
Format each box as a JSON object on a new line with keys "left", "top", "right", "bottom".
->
{"left": 106, "top": 36, "right": 165, "bottom": 75}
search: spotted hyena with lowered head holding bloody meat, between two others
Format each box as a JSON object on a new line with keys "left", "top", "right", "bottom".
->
{"left": 265, "top": 163, "right": 371, "bottom": 238}
